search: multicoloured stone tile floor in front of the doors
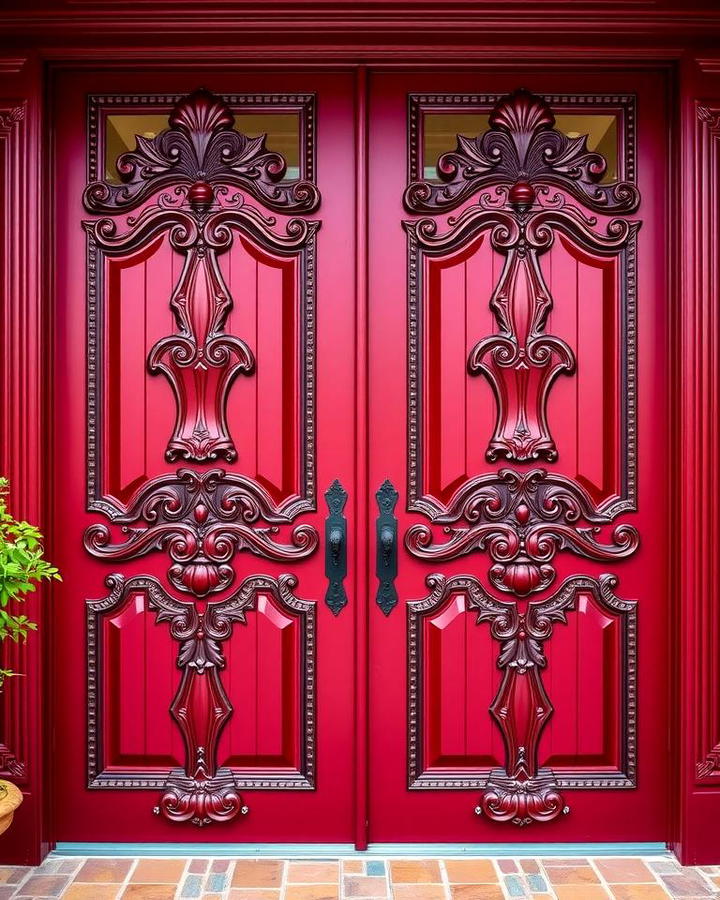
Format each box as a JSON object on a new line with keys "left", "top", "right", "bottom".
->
{"left": 0, "top": 855, "right": 720, "bottom": 900}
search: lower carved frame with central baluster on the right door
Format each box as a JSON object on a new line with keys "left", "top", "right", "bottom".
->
{"left": 408, "top": 574, "right": 636, "bottom": 825}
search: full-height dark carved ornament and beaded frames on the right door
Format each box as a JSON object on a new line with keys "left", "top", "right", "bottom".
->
{"left": 404, "top": 90, "right": 640, "bottom": 825}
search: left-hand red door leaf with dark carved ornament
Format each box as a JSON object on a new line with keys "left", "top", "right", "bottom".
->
{"left": 52, "top": 73, "right": 355, "bottom": 842}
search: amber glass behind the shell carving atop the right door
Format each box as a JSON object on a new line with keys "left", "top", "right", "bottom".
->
{"left": 422, "top": 112, "right": 619, "bottom": 181}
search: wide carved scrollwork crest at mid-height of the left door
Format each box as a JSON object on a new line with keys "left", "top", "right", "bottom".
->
{"left": 84, "top": 469, "right": 319, "bottom": 597}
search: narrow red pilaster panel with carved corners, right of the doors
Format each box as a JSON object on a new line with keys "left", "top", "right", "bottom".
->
{"left": 679, "top": 101, "right": 720, "bottom": 786}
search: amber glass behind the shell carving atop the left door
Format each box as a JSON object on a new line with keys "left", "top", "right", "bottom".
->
{"left": 105, "top": 112, "right": 300, "bottom": 184}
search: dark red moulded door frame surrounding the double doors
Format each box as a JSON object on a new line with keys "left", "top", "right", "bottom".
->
{"left": 0, "top": 17, "right": 720, "bottom": 864}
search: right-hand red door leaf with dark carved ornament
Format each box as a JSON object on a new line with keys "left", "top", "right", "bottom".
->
{"left": 369, "top": 73, "right": 669, "bottom": 842}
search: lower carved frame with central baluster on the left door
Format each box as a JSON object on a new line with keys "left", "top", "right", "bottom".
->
{"left": 87, "top": 574, "right": 315, "bottom": 825}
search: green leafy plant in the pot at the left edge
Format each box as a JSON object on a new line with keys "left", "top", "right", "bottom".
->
{"left": 0, "top": 478, "right": 62, "bottom": 687}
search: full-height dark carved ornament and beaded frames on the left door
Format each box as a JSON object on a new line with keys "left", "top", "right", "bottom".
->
{"left": 83, "top": 90, "right": 320, "bottom": 825}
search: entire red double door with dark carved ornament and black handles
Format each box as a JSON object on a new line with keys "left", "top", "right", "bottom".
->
{"left": 48, "top": 70, "right": 670, "bottom": 846}
